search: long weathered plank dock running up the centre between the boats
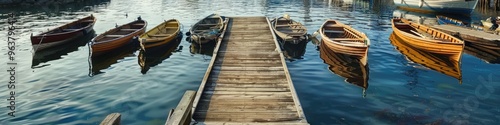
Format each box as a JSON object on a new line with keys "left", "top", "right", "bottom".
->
{"left": 192, "top": 17, "right": 308, "bottom": 125}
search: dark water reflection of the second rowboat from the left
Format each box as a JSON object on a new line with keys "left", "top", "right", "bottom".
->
{"left": 89, "top": 42, "right": 139, "bottom": 77}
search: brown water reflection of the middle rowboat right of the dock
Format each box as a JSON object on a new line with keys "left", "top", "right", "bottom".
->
{"left": 319, "top": 41, "right": 369, "bottom": 97}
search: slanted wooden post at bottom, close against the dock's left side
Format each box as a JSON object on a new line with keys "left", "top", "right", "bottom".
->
{"left": 165, "top": 90, "right": 196, "bottom": 125}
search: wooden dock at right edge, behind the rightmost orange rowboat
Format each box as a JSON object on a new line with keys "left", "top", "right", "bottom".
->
{"left": 432, "top": 25, "right": 500, "bottom": 50}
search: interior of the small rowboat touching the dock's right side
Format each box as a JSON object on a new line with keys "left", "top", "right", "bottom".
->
{"left": 275, "top": 18, "right": 307, "bottom": 36}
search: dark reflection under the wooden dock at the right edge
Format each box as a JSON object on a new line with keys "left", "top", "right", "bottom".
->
{"left": 464, "top": 42, "right": 500, "bottom": 64}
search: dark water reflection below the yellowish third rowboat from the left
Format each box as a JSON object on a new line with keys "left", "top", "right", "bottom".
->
{"left": 137, "top": 34, "right": 182, "bottom": 74}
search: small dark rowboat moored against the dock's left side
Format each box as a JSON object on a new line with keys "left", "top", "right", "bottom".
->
{"left": 186, "top": 14, "right": 224, "bottom": 44}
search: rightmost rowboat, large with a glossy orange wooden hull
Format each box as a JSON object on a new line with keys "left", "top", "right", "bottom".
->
{"left": 392, "top": 18, "right": 464, "bottom": 61}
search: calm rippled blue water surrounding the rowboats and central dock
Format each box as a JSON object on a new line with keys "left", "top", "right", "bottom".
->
{"left": 0, "top": 0, "right": 500, "bottom": 125}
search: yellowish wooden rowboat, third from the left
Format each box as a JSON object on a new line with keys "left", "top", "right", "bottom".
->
{"left": 139, "top": 19, "right": 181, "bottom": 50}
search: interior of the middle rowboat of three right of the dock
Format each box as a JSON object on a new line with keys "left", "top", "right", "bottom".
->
{"left": 323, "top": 21, "right": 365, "bottom": 44}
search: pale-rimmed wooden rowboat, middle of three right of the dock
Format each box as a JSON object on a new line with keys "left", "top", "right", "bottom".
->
{"left": 319, "top": 20, "right": 370, "bottom": 65}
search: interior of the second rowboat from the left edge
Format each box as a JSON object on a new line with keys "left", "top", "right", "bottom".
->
{"left": 96, "top": 20, "right": 146, "bottom": 42}
